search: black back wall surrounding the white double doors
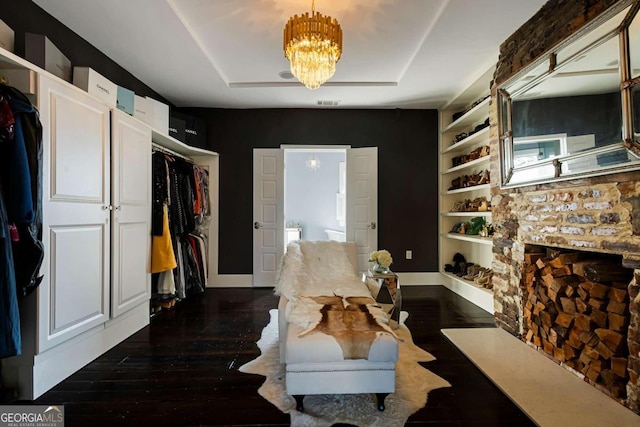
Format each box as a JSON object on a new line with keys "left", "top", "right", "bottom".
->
{"left": 184, "top": 108, "right": 438, "bottom": 274}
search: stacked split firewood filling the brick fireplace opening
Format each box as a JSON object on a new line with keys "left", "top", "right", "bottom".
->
{"left": 524, "top": 250, "right": 632, "bottom": 397}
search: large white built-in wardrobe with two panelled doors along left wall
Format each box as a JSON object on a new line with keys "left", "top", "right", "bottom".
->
{"left": 0, "top": 42, "right": 218, "bottom": 399}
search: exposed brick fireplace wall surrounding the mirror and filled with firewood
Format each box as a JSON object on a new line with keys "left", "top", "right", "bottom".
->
{"left": 490, "top": 0, "right": 640, "bottom": 414}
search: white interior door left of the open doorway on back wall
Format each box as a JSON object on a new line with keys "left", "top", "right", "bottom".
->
{"left": 252, "top": 148, "right": 284, "bottom": 286}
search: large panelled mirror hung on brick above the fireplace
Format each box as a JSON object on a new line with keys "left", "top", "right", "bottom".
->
{"left": 498, "top": 1, "right": 640, "bottom": 187}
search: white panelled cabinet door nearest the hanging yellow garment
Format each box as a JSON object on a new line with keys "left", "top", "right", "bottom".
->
{"left": 111, "top": 110, "right": 151, "bottom": 317}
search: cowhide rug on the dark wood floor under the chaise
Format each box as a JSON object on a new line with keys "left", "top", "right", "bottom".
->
{"left": 239, "top": 310, "right": 451, "bottom": 427}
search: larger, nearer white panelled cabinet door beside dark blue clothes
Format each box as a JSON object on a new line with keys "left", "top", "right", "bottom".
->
{"left": 37, "top": 76, "right": 110, "bottom": 352}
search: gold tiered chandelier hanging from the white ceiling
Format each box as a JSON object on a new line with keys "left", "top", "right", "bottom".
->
{"left": 283, "top": 0, "right": 342, "bottom": 90}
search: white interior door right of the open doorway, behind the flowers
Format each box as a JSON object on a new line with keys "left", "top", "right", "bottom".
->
{"left": 346, "top": 147, "right": 378, "bottom": 271}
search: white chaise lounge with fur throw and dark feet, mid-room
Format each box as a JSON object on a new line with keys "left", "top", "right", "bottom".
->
{"left": 276, "top": 241, "right": 398, "bottom": 411}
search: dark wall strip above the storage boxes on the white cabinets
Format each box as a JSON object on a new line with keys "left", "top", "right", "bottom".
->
{"left": 0, "top": 0, "right": 171, "bottom": 105}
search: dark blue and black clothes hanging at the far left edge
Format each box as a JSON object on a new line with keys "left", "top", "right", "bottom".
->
{"left": 0, "top": 84, "right": 44, "bottom": 357}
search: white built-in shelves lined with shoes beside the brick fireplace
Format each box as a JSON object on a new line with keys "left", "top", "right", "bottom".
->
{"left": 439, "top": 67, "right": 495, "bottom": 313}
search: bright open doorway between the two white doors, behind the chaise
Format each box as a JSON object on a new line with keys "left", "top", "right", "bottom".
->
{"left": 284, "top": 148, "right": 347, "bottom": 246}
